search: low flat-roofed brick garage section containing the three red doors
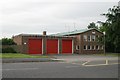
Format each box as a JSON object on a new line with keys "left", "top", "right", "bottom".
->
{"left": 13, "top": 34, "right": 75, "bottom": 54}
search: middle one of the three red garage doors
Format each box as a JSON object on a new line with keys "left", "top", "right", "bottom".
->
{"left": 46, "top": 39, "right": 58, "bottom": 54}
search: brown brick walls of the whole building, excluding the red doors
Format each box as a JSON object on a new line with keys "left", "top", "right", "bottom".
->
{"left": 13, "top": 29, "right": 104, "bottom": 54}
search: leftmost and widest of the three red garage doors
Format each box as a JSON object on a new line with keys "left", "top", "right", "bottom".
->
{"left": 28, "top": 39, "right": 42, "bottom": 54}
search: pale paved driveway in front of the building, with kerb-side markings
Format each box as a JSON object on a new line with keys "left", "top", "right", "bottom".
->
{"left": 52, "top": 54, "right": 119, "bottom": 66}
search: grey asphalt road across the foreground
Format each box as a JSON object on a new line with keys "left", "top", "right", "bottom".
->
{"left": 2, "top": 62, "right": 118, "bottom": 78}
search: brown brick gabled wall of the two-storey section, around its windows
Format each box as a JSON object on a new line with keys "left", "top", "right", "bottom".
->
{"left": 69, "top": 29, "right": 104, "bottom": 54}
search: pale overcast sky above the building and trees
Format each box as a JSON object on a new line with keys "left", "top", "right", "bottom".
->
{"left": 0, "top": 0, "right": 119, "bottom": 37}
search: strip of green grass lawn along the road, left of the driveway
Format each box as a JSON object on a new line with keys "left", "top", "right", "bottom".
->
{"left": 0, "top": 53, "right": 48, "bottom": 58}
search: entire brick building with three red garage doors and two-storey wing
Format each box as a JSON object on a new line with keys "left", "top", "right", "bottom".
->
{"left": 13, "top": 29, "right": 104, "bottom": 54}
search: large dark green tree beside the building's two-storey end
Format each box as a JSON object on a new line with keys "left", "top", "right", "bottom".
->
{"left": 100, "top": 6, "right": 120, "bottom": 52}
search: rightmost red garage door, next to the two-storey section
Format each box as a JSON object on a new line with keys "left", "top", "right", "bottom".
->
{"left": 62, "top": 39, "right": 72, "bottom": 54}
